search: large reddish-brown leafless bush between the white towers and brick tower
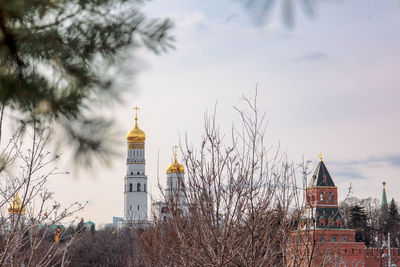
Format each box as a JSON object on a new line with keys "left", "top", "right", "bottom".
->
{"left": 140, "top": 94, "right": 308, "bottom": 266}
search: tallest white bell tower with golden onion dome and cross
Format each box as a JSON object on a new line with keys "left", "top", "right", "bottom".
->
{"left": 124, "top": 107, "right": 147, "bottom": 221}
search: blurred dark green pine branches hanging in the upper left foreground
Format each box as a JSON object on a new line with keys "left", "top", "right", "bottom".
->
{"left": 0, "top": 0, "right": 172, "bottom": 163}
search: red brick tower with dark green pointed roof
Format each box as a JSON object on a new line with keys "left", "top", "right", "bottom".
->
{"left": 292, "top": 156, "right": 365, "bottom": 266}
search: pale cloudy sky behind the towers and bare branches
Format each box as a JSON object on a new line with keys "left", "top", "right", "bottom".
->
{"left": 5, "top": 0, "right": 400, "bottom": 224}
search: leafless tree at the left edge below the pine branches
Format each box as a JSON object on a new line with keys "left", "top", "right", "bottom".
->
{"left": 0, "top": 119, "right": 83, "bottom": 266}
